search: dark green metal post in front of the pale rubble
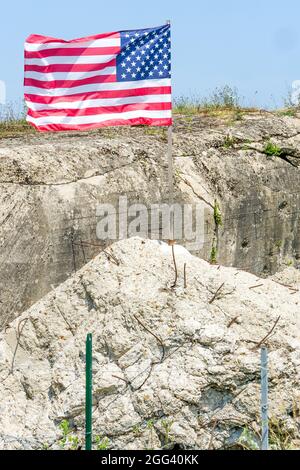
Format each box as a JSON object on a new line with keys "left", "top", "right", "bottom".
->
{"left": 85, "top": 333, "right": 93, "bottom": 450}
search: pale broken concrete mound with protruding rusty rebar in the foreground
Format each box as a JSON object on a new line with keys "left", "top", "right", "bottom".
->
{"left": 0, "top": 238, "right": 300, "bottom": 450}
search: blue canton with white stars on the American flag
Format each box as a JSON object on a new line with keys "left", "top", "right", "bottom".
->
{"left": 117, "top": 25, "right": 171, "bottom": 82}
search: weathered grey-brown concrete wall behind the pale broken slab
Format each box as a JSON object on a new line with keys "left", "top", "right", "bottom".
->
{"left": 0, "top": 112, "right": 300, "bottom": 326}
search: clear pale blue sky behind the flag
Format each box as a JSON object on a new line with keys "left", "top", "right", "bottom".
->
{"left": 0, "top": 0, "right": 300, "bottom": 107}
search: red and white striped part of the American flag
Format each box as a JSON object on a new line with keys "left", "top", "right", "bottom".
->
{"left": 24, "top": 33, "right": 172, "bottom": 131}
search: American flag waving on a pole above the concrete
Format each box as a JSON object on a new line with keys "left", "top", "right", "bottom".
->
{"left": 24, "top": 24, "right": 172, "bottom": 131}
